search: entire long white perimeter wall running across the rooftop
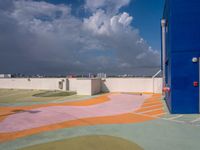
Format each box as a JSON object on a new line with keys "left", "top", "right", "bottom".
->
{"left": 0, "top": 78, "right": 162, "bottom": 95}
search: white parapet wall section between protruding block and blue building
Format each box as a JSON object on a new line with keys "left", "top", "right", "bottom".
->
{"left": 101, "top": 78, "right": 162, "bottom": 93}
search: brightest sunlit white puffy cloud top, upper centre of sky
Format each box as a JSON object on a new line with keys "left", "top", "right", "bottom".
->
{"left": 83, "top": 10, "right": 133, "bottom": 36}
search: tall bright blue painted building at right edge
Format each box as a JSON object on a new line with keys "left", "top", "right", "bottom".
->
{"left": 163, "top": 0, "right": 200, "bottom": 114}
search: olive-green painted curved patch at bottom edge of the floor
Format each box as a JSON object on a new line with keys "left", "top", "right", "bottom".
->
{"left": 21, "top": 135, "right": 142, "bottom": 150}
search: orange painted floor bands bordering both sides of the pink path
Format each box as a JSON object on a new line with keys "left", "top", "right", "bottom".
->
{"left": 0, "top": 93, "right": 165, "bottom": 142}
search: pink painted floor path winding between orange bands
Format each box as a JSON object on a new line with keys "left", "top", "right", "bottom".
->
{"left": 0, "top": 94, "right": 151, "bottom": 133}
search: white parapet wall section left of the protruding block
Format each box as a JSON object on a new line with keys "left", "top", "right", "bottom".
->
{"left": 0, "top": 78, "right": 68, "bottom": 91}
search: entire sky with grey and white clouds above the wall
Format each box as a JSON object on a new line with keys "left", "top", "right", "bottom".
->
{"left": 0, "top": 0, "right": 164, "bottom": 75}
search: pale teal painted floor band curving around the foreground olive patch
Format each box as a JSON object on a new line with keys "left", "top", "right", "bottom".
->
{"left": 0, "top": 119, "right": 200, "bottom": 150}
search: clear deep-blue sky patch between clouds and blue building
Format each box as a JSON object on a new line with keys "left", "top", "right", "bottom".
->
{"left": 129, "top": 0, "right": 164, "bottom": 50}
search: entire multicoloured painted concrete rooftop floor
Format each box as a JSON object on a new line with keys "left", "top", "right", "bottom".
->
{"left": 0, "top": 90, "right": 200, "bottom": 150}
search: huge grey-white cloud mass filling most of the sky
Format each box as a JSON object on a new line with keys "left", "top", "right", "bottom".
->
{"left": 0, "top": 0, "right": 160, "bottom": 74}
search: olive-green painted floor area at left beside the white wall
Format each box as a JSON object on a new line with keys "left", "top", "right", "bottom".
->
{"left": 0, "top": 89, "right": 90, "bottom": 106}
